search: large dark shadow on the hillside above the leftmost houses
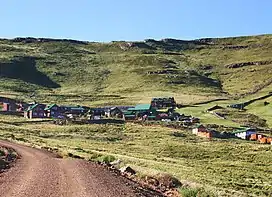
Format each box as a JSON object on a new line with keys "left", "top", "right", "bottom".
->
{"left": 0, "top": 57, "right": 60, "bottom": 88}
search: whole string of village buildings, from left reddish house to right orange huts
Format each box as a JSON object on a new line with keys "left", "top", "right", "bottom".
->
{"left": 0, "top": 97, "right": 272, "bottom": 144}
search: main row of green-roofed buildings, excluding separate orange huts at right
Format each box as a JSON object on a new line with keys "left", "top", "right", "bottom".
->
{"left": 0, "top": 97, "right": 194, "bottom": 123}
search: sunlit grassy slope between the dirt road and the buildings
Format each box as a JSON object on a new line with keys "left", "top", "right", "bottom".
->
{"left": 0, "top": 115, "right": 272, "bottom": 196}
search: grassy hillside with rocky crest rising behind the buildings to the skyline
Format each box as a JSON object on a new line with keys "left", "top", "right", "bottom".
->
{"left": 0, "top": 35, "right": 272, "bottom": 105}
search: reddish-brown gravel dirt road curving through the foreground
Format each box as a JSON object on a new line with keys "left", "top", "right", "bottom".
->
{"left": 0, "top": 140, "right": 161, "bottom": 197}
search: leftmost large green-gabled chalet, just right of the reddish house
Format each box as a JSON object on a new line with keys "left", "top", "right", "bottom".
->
{"left": 24, "top": 104, "right": 46, "bottom": 119}
